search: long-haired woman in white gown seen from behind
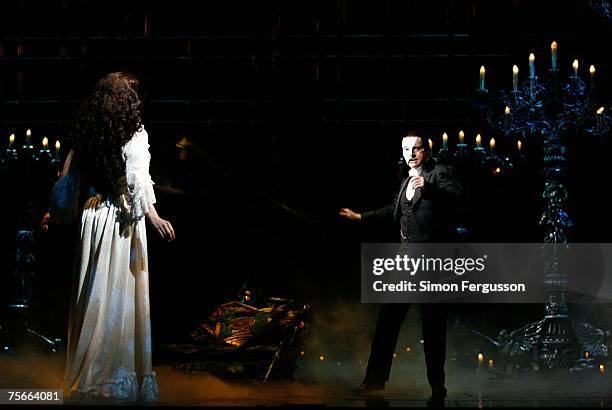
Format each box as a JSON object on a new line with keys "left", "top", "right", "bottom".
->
{"left": 50, "top": 73, "right": 174, "bottom": 402}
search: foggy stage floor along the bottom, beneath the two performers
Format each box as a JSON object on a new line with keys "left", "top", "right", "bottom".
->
{"left": 0, "top": 352, "right": 612, "bottom": 408}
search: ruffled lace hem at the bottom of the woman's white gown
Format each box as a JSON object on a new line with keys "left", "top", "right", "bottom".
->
{"left": 66, "top": 372, "right": 159, "bottom": 402}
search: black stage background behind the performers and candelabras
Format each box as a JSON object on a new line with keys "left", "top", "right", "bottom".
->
{"left": 0, "top": 0, "right": 612, "bottom": 356}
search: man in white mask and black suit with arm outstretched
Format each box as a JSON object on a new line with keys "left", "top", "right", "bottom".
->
{"left": 340, "top": 131, "right": 463, "bottom": 402}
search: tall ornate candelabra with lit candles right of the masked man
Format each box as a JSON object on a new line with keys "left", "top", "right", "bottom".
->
{"left": 474, "top": 42, "right": 612, "bottom": 371}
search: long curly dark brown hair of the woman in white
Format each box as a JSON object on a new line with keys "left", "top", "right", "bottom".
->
{"left": 68, "top": 72, "right": 142, "bottom": 199}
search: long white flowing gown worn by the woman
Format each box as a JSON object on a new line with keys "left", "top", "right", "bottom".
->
{"left": 63, "top": 128, "right": 159, "bottom": 401}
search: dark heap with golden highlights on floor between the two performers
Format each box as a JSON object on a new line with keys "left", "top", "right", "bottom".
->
{"left": 161, "top": 298, "right": 310, "bottom": 382}
